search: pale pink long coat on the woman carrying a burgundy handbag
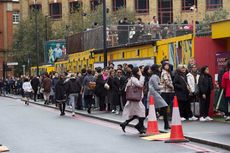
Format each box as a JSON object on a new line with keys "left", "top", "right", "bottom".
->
{"left": 122, "top": 76, "right": 145, "bottom": 120}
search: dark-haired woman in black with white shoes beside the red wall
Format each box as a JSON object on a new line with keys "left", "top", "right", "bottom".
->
{"left": 198, "top": 66, "right": 213, "bottom": 121}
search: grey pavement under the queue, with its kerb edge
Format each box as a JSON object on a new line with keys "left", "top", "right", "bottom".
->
{"left": 5, "top": 95, "right": 230, "bottom": 151}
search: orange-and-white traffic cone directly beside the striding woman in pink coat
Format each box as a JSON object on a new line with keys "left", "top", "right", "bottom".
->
{"left": 146, "top": 96, "right": 160, "bottom": 135}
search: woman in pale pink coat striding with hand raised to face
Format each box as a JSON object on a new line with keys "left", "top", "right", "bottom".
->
{"left": 120, "top": 67, "right": 145, "bottom": 134}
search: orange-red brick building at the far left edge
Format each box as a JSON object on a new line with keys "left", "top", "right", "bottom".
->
{"left": 0, "top": 0, "right": 20, "bottom": 78}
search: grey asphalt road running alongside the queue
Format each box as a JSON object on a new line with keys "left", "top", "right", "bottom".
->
{"left": 0, "top": 97, "right": 227, "bottom": 153}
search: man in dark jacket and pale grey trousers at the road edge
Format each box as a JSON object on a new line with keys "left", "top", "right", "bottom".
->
{"left": 66, "top": 74, "right": 81, "bottom": 116}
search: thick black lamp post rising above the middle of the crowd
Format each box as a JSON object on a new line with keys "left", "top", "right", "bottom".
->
{"left": 103, "top": 0, "right": 107, "bottom": 68}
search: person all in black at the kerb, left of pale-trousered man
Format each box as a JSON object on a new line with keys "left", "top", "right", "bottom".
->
{"left": 55, "top": 75, "right": 66, "bottom": 116}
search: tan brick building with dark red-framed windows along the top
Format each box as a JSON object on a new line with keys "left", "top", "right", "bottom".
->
{"left": 21, "top": 0, "right": 230, "bottom": 23}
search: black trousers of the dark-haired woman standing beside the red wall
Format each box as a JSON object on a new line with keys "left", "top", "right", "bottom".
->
{"left": 200, "top": 94, "right": 210, "bottom": 117}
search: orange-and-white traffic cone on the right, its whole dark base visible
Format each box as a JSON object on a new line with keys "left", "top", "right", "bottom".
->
{"left": 165, "top": 96, "right": 189, "bottom": 143}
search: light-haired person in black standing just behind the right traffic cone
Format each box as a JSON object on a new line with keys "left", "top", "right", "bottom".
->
{"left": 173, "top": 65, "right": 192, "bottom": 121}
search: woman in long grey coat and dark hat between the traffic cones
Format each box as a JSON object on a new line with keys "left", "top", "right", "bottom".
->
{"left": 147, "top": 64, "right": 170, "bottom": 130}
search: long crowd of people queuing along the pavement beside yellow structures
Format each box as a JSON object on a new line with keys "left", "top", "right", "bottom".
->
{"left": 0, "top": 58, "right": 230, "bottom": 133}
